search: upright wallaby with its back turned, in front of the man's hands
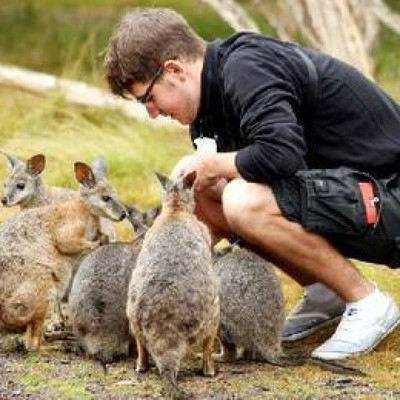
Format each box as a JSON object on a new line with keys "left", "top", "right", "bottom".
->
{"left": 127, "top": 173, "right": 219, "bottom": 399}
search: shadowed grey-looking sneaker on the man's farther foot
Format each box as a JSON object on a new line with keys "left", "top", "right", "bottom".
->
{"left": 282, "top": 283, "right": 346, "bottom": 342}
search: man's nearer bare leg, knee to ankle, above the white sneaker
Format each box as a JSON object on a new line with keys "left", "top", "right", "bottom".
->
{"left": 223, "top": 179, "right": 374, "bottom": 302}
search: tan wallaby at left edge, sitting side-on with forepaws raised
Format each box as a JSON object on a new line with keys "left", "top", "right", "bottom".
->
{"left": 0, "top": 162, "right": 126, "bottom": 349}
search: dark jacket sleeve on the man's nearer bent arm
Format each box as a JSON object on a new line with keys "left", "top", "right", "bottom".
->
{"left": 222, "top": 49, "right": 306, "bottom": 183}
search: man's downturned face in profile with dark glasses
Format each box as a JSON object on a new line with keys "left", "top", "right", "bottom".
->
{"left": 131, "top": 60, "right": 200, "bottom": 125}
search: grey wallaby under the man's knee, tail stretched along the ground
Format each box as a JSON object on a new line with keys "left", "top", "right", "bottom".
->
{"left": 213, "top": 248, "right": 363, "bottom": 375}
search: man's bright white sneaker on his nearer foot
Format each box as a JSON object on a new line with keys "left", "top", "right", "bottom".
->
{"left": 311, "top": 288, "right": 400, "bottom": 360}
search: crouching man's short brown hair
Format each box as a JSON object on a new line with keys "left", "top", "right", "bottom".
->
{"left": 105, "top": 8, "right": 206, "bottom": 97}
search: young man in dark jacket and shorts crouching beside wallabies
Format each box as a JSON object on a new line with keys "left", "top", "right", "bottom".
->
{"left": 105, "top": 9, "right": 400, "bottom": 359}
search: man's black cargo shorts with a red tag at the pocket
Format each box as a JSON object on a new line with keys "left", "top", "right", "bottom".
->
{"left": 272, "top": 168, "right": 400, "bottom": 268}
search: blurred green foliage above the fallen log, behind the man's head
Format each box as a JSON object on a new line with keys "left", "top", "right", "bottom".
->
{"left": 0, "top": 0, "right": 232, "bottom": 85}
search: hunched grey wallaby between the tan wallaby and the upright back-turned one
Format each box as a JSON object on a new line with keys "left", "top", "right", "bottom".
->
{"left": 68, "top": 206, "right": 159, "bottom": 365}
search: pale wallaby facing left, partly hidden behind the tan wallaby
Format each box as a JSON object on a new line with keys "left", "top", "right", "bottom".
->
{"left": 1, "top": 152, "right": 117, "bottom": 242}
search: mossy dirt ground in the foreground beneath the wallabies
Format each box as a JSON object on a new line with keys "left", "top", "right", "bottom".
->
{"left": 0, "top": 324, "right": 400, "bottom": 400}
